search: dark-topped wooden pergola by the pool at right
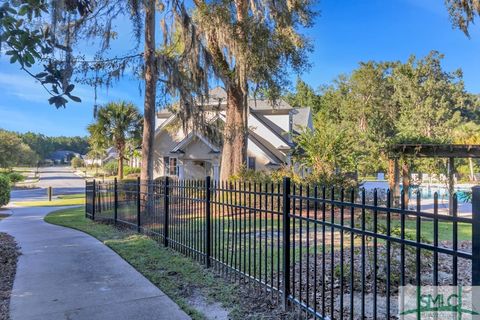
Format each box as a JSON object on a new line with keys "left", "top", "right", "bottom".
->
{"left": 389, "top": 144, "right": 480, "bottom": 213}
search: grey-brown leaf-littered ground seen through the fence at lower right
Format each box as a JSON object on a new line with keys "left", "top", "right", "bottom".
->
{"left": 291, "top": 241, "right": 472, "bottom": 319}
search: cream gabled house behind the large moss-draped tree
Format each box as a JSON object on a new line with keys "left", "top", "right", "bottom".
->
{"left": 154, "top": 88, "right": 312, "bottom": 180}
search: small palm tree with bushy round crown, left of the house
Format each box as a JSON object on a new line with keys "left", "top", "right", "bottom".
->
{"left": 88, "top": 101, "right": 143, "bottom": 179}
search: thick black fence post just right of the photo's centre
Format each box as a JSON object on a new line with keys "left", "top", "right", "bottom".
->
{"left": 282, "top": 177, "right": 290, "bottom": 310}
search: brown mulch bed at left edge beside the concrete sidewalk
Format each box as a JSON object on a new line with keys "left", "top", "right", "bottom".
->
{"left": 0, "top": 232, "right": 20, "bottom": 320}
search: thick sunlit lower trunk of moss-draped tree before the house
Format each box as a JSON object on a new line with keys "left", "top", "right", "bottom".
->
{"left": 220, "top": 85, "right": 248, "bottom": 181}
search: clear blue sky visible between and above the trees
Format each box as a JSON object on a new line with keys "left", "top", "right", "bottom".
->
{"left": 0, "top": 0, "right": 480, "bottom": 135}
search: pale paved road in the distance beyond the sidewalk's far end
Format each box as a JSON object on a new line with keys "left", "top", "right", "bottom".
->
{"left": 12, "top": 167, "right": 85, "bottom": 201}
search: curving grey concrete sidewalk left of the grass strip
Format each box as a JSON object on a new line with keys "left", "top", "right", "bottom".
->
{"left": 0, "top": 207, "right": 189, "bottom": 320}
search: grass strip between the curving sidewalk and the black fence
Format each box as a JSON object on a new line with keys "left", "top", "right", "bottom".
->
{"left": 45, "top": 207, "right": 258, "bottom": 319}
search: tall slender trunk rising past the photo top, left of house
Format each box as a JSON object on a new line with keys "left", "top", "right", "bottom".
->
{"left": 140, "top": 1, "right": 157, "bottom": 185}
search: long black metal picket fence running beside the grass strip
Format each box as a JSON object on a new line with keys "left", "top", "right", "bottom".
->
{"left": 86, "top": 178, "right": 480, "bottom": 319}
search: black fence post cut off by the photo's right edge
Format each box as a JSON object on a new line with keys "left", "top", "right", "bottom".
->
{"left": 472, "top": 186, "right": 480, "bottom": 312}
